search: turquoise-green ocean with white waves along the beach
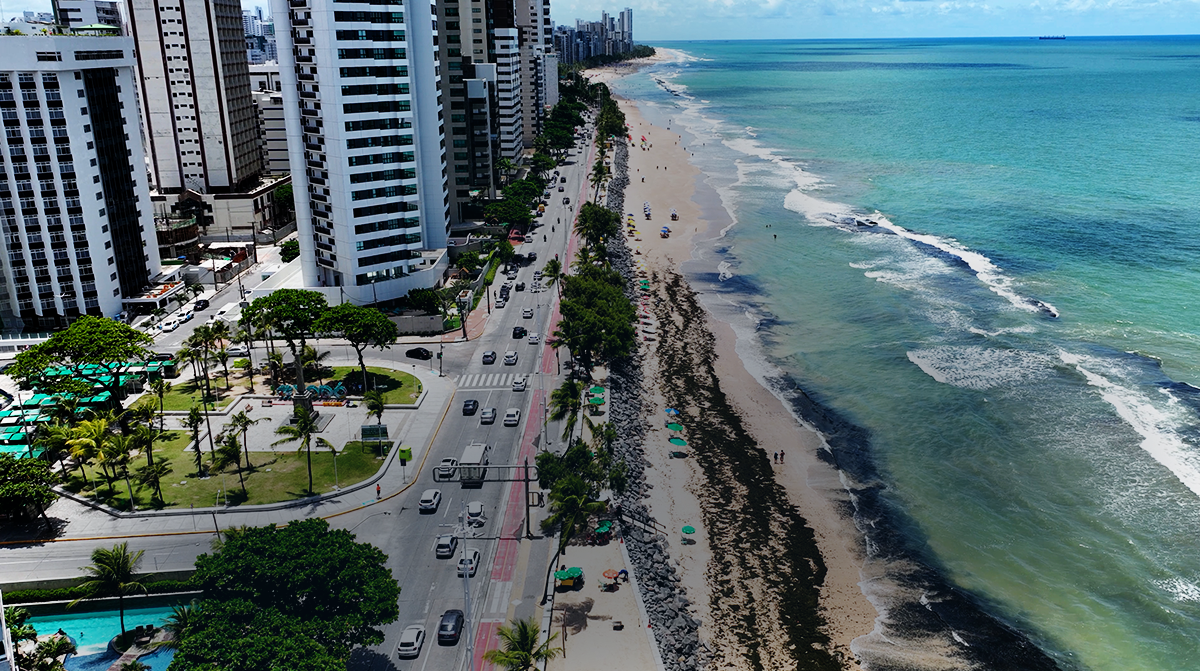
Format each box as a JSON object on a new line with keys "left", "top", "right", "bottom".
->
{"left": 613, "top": 37, "right": 1200, "bottom": 671}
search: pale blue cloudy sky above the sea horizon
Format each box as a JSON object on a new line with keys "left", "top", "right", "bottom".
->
{"left": 9, "top": 0, "right": 1200, "bottom": 44}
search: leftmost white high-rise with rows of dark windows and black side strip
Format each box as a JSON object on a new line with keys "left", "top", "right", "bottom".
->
{"left": 0, "top": 36, "right": 160, "bottom": 330}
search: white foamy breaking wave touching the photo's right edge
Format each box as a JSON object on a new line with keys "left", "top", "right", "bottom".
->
{"left": 1058, "top": 352, "right": 1200, "bottom": 496}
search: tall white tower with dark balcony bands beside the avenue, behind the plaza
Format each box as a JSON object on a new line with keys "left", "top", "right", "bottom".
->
{"left": 271, "top": 0, "right": 450, "bottom": 304}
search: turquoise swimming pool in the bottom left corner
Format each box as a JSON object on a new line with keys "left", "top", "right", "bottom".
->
{"left": 30, "top": 606, "right": 175, "bottom": 671}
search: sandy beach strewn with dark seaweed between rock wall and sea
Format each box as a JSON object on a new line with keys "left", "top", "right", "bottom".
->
{"left": 587, "top": 60, "right": 877, "bottom": 669}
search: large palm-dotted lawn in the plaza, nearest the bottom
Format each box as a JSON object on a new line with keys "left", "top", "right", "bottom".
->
{"left": 58, "top": 431, "right": 386, "bottom": 510}
